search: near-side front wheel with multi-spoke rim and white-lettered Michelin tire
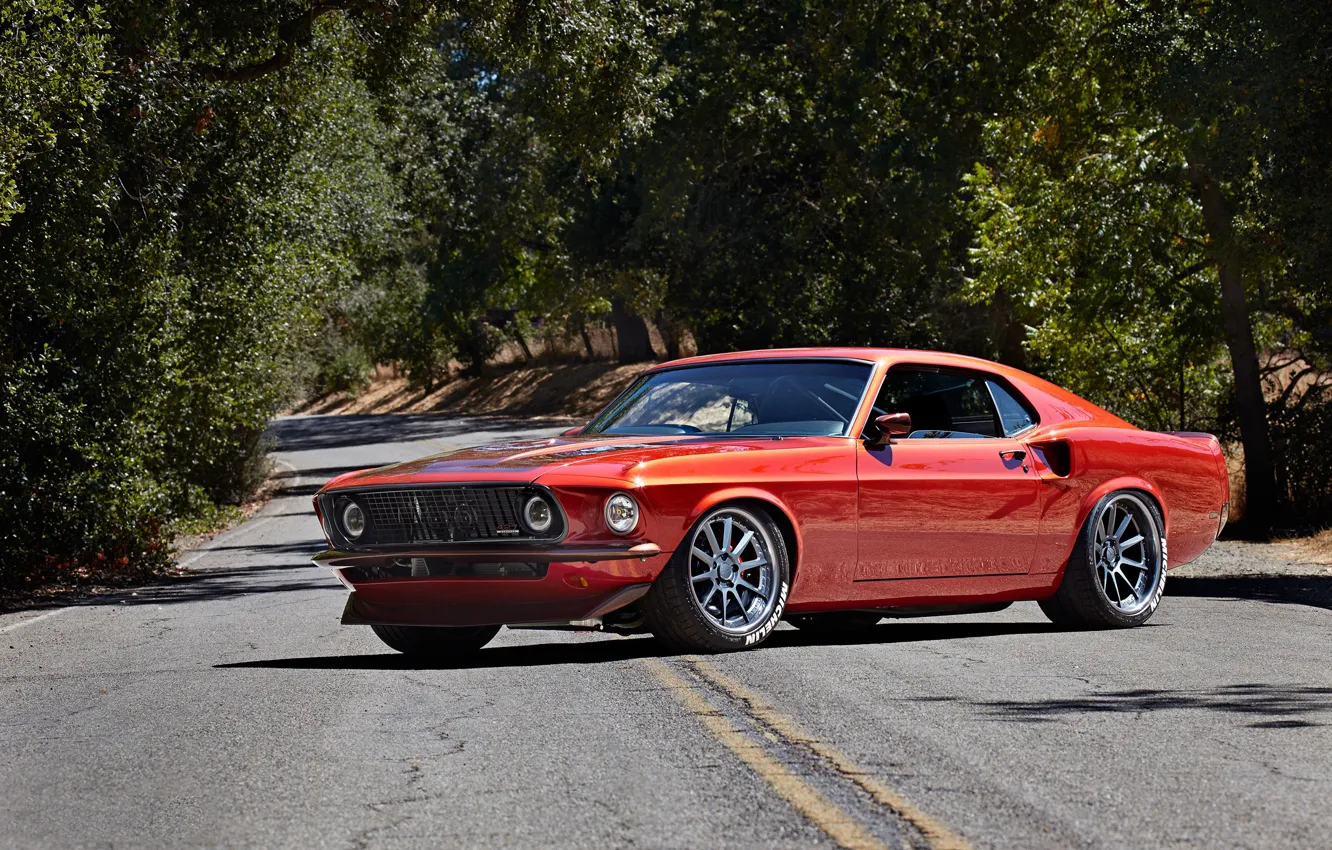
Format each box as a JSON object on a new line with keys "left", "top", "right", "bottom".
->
{"left": 643, "top": 505, "right": 790, "bottom": 651}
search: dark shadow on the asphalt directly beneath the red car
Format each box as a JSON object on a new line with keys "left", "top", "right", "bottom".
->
{"left": 213, "top": 622, "right": 1059, "bottom": 670}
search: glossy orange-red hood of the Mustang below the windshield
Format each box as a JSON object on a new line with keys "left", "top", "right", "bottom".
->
{"left": 325, "top": 434, "right": 815, "bottom": 489}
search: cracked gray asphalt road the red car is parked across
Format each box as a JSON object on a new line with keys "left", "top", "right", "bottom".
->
{"left": 0, "top": 417, "right": 1332, "bottom": 849}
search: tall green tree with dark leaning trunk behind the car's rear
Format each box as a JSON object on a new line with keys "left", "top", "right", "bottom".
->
{"left": 971, "top": 0, "right": 1332, "bottom": 537}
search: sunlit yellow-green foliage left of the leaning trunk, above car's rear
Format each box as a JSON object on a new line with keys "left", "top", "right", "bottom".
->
{"left": 967, "top": 121, "right": 1225, "bottom": 429}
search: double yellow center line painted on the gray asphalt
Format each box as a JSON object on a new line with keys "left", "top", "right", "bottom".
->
{"left": 645, "top": 657, "right": 970, "bottom": 850}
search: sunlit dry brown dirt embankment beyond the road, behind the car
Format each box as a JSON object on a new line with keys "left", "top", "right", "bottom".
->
{"left": 290, "top": 362, "right": 653, "bottom": 420}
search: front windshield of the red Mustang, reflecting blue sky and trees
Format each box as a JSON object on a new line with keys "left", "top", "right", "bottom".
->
{"left": 582, "top": 360, "right": 871, "bottom": 437}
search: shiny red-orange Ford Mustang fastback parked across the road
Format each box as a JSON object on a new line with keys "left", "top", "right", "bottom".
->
{"left": 314, "top": 348, "right": 1229, "bottom": 657}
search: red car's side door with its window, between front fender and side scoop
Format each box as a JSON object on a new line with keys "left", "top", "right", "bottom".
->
{"left": 856, "top": 365, "right": 1040, "bottom": 580}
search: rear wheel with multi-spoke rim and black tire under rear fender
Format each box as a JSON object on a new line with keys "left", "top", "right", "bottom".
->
{"left": 1039, "top": 490, "right": 1167, "bottom": 629}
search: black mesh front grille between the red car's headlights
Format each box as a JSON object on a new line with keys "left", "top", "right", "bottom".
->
{"left": 338, "top": 486, "right": 563, "bottom": 546}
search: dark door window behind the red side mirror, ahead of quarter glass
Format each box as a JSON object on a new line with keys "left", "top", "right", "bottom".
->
{"left": 874, "top": 366, "right": 1001, "bottom": 440}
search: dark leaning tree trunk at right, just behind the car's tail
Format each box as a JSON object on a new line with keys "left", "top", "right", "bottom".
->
{"left": 1189, "top": 165, "right": 1276, "bottom": 540}
